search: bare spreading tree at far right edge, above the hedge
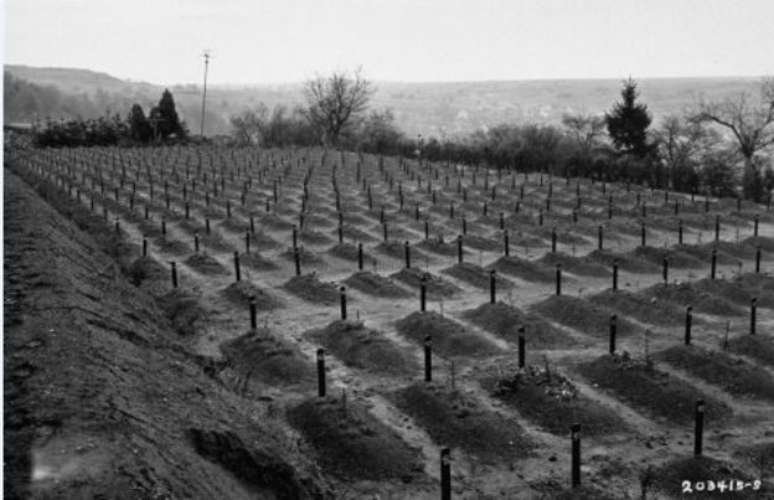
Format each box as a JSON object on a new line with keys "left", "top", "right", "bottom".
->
{"left": 691, "top": 78, "right": 774, "bottom": 196}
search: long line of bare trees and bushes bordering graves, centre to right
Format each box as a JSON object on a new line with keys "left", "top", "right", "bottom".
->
{"left": 231, "top": 71, "right": 774, "bottom": 201}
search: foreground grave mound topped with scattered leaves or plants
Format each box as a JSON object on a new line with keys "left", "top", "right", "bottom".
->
{"left": 482, "top": 365, "right": 628, "bottom": 436}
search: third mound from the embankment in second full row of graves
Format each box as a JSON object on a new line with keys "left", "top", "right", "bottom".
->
{"left": 395, "top": 311, "right": 499, "bottom": 357}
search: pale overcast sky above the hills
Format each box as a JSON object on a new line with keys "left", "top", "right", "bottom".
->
{"left": 4, "top": 0, "right": 774, "bottom": 83}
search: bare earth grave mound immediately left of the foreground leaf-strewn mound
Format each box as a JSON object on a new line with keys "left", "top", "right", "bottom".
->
{"left": 392, "top": 383, "right": 534, "bottom": 463}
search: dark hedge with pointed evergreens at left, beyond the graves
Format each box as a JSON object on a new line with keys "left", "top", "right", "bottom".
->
{"left": 33, "top": 89, "right": 189, "bottom": 147}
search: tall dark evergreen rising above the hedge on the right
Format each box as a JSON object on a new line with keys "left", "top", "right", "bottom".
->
{"left": 605, "top": 77, "right": 653, "bottom": 158}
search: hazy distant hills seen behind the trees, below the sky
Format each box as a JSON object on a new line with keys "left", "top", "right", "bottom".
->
{"left": 4, "top": 65, "right": 759, "bottom": 137}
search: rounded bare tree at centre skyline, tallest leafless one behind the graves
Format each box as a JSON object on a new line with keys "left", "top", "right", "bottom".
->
{"left": 304, "top": 69, "right": 373, "bottom": 145}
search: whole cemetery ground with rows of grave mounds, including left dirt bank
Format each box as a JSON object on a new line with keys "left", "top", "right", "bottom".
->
{"left": 4, "top": 143, "right": 774, "bottom": 499}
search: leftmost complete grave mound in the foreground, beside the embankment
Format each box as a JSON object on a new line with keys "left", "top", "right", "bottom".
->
{"left": 288, "top": 398, "right": 423, "bottom": 482}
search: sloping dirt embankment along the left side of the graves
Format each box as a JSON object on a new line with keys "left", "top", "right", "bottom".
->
{"left": 4, "top": 170, "right": 332, "bottom": 499}
